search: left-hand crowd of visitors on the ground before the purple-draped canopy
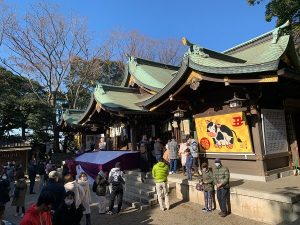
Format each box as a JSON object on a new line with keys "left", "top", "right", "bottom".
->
{"left": 0, "top": 159, "right": 125, "bottom": 225}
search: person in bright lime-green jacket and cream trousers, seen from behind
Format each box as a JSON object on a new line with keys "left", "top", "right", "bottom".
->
{"left": 152, "top": 157, "right": 170, "bottom": 211}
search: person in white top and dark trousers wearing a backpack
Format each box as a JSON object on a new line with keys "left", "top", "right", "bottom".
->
{"left": 106, "top": 162, "right": 125, "bottom": 215}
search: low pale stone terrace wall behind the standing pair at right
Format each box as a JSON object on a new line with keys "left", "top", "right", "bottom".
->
{"left": 169, "top": 178, "right": 300, "bottom": 224}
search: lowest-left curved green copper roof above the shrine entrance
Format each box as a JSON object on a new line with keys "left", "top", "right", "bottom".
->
{"left": 94, "top": 84, "right": 152, "bottom": 111}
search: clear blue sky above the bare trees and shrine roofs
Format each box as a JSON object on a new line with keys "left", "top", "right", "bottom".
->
{"left": 4, "top": 0, "right": 275, "bottom": 51}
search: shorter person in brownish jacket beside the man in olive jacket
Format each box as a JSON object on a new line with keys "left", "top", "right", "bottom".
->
{"left": 201, "top": 163, "right": 214, "bottom": 212}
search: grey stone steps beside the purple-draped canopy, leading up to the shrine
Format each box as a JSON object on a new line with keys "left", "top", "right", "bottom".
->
{"left": 123, "top": 170, "right": 175, "bottom": 210}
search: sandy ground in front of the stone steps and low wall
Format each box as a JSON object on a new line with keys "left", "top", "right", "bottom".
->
{"left": 5, "top": 183, "right": 264, "bottom": 225}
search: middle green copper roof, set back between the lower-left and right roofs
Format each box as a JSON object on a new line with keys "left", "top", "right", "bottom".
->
{"left": 128, "top": 56, "right": 179, "bottom": 91}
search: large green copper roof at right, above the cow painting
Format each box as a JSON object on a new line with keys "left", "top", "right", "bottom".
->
{"left": 185, "top": 35, "right": 290, "bottom": 74}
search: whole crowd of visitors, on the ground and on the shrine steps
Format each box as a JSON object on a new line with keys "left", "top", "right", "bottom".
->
{"left": 0, "top": 135, "right": 229, "bottom": 225}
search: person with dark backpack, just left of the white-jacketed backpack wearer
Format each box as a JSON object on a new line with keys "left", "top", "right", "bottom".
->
{"left": 95, "top": 170, "right": 109, "bottom": 214}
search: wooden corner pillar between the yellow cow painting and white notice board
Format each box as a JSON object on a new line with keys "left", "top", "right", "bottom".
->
{"left": 251, "top": 108, "right": 267, "bottom": 176}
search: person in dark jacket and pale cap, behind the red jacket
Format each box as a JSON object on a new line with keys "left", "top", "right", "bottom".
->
{"left": 41, "top": 170, "right": 66, "bottom": 211}
